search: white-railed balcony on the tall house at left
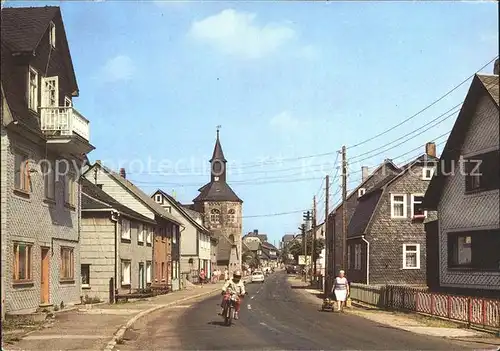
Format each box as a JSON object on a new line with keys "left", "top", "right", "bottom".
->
{"left": 40, "top": 106, "right": 94, "bottom": 153}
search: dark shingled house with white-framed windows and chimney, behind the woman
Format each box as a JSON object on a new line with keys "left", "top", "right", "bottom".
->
{"left": 347, "top": 143, "right": 437, "bottom": 285}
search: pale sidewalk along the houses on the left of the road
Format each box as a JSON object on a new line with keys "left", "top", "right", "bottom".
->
{"left": 2, "top": 282, "right": 223, "bottom": 350}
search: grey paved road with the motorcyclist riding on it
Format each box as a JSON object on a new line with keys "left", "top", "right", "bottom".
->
{"left": 116, "top": 273, "right": 496, "bottom": 350}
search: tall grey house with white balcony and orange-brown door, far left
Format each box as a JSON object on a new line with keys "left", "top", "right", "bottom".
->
{"left": 0, "top": 7, "right": 94, "bottom": 314}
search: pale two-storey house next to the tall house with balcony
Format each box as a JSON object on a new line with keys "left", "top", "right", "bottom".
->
{"left": 80, "top": 177, "right": 156, "bottom": 302}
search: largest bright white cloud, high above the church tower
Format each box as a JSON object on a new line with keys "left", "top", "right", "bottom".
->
{"left": 189, "top": 9, "right": 296, "bottom": 59}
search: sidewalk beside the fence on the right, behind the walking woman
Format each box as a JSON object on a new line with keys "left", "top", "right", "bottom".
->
{"left": 288, "top": 278, "right": 500, "bottom": 345}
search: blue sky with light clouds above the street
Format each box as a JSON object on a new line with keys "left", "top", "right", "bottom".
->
{"left": 8, "top": 1, "right": 498, "bottom": 246}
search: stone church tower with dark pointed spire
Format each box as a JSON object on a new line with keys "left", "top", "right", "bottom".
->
{"left": 193, "top": 127, "right": 243, "bottom": 273}
